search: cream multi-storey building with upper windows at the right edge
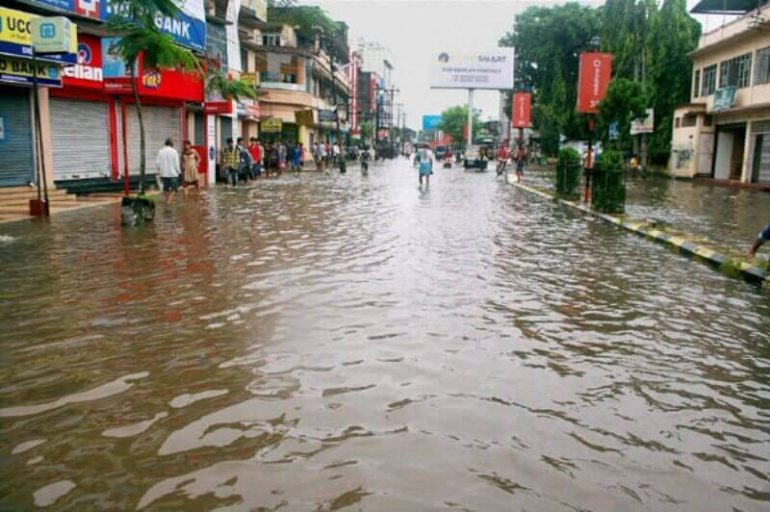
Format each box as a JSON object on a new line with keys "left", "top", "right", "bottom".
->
{"left": 669, "top": 2, "right": 770, "bottom": 185}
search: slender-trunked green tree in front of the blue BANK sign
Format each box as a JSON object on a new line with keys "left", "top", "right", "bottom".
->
{"left": 107, "top": 0, "right": 201, "bottom": 195}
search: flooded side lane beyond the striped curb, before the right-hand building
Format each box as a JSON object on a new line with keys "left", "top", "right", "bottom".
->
{"left": 529, "top": 165, "right": 770, "bottom": 256}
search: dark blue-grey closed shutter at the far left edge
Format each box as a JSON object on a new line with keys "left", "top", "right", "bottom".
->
{"left": 0, "top": 87, "right": 35, "bottom": 187}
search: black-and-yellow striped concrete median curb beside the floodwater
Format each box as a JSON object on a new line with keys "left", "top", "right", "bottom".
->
{"left": 508, "top": 176, "right": 770, "bottom": 288}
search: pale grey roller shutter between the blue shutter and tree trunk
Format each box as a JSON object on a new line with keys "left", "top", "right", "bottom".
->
{"left": 51, "top": 98, "right": 110, "bottom": 180}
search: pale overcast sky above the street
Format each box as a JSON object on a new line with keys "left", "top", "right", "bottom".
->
{"left": 300, "top": 0, "right": 722, "bottom": 129}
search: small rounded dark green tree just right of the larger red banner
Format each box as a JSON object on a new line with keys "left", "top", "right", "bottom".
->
{"left": 597, "top": 78, "right": 648, "bottom": 150}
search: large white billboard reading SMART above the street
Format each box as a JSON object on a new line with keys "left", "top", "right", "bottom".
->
{"left": 431, "top": 48, "right": 513, "bottom": 89}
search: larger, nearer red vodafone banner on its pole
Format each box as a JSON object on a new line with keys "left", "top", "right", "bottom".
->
{"left": 576, "top": 52, "right": 612, "bottom": 203}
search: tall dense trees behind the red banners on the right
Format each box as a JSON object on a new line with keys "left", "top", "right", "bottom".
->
{"left": 500, "top": 0, "right": 700, "bottom": 160}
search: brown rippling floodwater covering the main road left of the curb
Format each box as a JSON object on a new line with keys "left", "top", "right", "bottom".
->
{"left": 0, "top": 161, "right": 770, "bottom": 511}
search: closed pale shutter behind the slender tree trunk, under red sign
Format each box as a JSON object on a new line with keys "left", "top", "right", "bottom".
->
{"left": 118, "top": 105, "right": 182, "bottom": 176}
